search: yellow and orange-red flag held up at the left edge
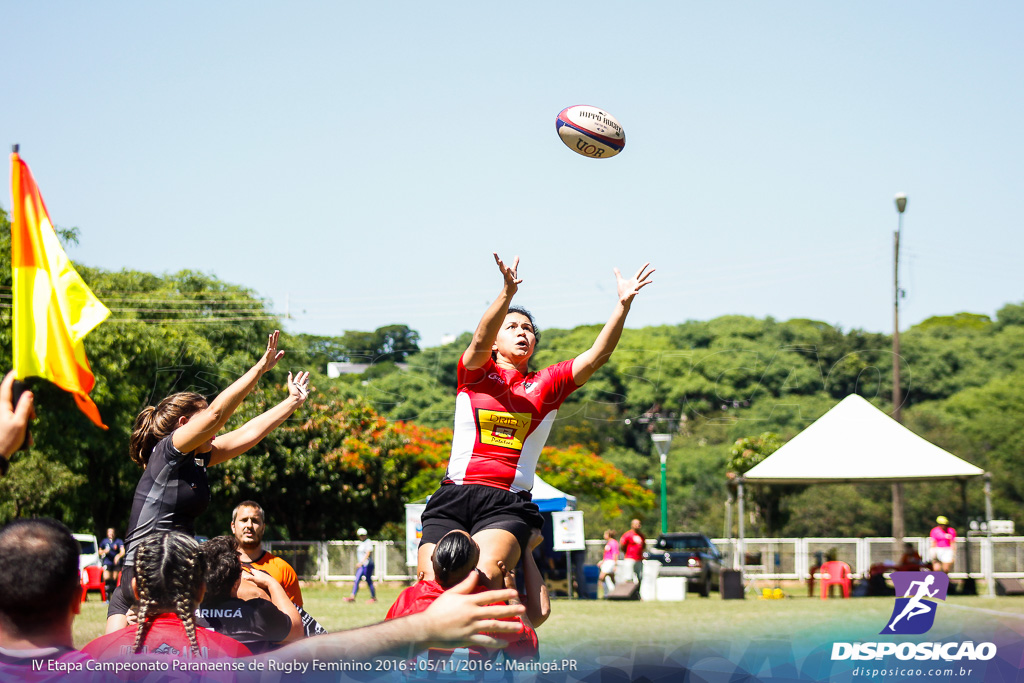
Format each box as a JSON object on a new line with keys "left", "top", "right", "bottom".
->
{"left": 10, "top": 152, "right": 111, "bottom": 429}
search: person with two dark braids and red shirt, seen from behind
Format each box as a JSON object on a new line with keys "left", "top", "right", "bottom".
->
{"left": 82, "top": 531, "right": 252, "bottom": 659}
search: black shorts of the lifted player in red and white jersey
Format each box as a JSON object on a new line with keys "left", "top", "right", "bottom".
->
{"left": 420, "top": 484, "right": 544, "bottom": 548}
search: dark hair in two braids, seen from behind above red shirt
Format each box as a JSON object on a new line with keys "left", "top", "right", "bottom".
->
{"left": 132, "top": 531, "right": 206, "bottom": 657}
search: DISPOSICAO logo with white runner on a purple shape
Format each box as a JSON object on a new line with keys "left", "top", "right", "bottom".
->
{"left": 831, "top": 571, "right": 995, "bottom": 661}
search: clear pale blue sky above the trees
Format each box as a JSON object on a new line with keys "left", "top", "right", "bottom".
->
{"left": 0, "top": 0, "right": 1024, "bottom": 345}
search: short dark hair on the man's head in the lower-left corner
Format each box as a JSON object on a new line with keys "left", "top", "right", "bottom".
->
{"left": 0, "top": 518, "right": 82, "bottom": 635}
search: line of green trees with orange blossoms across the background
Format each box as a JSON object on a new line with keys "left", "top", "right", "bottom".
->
{"left": 0, "top": 209, "right": 1024, "bottom": 540}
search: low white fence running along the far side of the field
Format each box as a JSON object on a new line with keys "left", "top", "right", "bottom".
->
{"left": 266, "top": 536, "right": 1024, "bottom": 582}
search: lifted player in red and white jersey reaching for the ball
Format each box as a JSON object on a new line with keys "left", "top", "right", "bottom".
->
{"left": 418, "top": 254, "right": 654, "bottom": 588}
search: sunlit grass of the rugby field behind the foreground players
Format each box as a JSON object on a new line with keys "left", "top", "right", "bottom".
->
{"left": 75, "top": 584, "right": 1024, "bottom": 659}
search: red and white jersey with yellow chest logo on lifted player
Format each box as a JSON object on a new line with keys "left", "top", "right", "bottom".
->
{"left": 444, "top": 357, "right": 578, "bottom": 493}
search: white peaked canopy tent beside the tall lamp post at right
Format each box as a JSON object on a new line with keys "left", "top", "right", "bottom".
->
{"left": 737, "top": 394, "right": 994, "bottom": 595}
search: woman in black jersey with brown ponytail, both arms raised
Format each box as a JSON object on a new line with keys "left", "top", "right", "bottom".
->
{"left": 106, "top": 331, "right": 309, "bottom": 633}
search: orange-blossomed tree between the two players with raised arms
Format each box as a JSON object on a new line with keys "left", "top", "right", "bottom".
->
{"left": 209, "top": 387, "right": 420, "bottom": 540}
